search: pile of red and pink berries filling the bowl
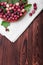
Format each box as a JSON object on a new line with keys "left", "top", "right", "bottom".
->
{"left": 0, "top": 2, "right": 25, "bottom": 22}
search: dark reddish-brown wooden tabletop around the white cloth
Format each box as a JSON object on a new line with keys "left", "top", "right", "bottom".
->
{"left": 0, "top": 11, "right": 43, "bottom": 65}
